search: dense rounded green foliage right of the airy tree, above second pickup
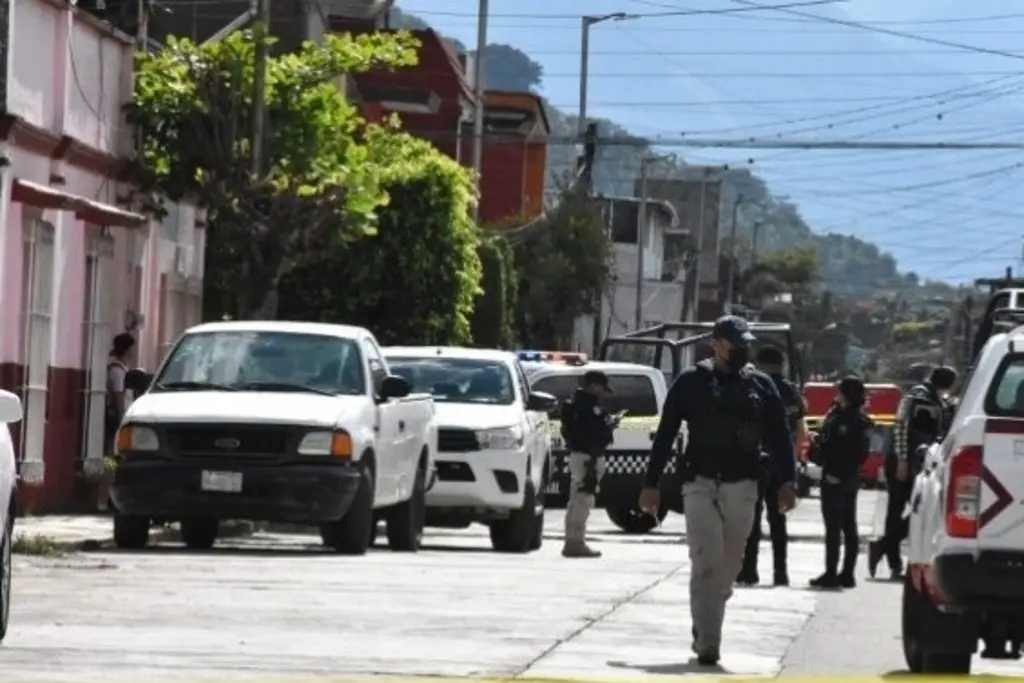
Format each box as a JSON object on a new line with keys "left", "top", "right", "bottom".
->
{"left": 281, "top": 123, "right": 481, "bottom": 345}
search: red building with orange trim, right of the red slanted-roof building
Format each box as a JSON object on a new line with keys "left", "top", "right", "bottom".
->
{"left": 475, "top": 90, "right": 551, "bottom": 223}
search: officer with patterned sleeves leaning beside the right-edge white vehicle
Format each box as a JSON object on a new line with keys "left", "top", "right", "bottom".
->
{"left": 867, "top": 366, "right": 956, "bottom": 579}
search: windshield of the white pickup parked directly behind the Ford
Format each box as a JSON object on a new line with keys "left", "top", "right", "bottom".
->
{"left": 387, "top": 357, "right": 515, "bottom": 405}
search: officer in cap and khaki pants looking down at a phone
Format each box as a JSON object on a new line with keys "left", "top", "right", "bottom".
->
{"left": 561, "top": 370, "right": 618, "bottom": 557}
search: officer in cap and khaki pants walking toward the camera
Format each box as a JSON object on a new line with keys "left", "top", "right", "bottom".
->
{"left": 640, "top": 315, "right": 797, "bottom": 666}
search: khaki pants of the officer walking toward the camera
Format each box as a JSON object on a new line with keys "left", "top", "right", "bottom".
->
{"left": 683, "top": 477, "right": 758, "bottom": 652}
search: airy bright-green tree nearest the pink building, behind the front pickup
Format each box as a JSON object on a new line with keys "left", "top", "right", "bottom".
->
{"left": 127, "top": 25, "right": 417, "bottom": 318}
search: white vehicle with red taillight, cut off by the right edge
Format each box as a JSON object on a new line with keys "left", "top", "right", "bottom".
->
{"left": 902, "top": 327, "right": 1024, "bottom": 674}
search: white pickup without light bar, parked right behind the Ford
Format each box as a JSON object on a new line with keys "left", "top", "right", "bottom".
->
{"left": 384, "top": 346, "right": 556, "bottom": 553}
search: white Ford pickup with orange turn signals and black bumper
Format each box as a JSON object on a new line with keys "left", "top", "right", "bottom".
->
{"left": 112, "top": 322, "right": 437, "bottom": 554}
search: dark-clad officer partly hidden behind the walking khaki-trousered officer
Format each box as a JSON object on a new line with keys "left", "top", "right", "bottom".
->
{"left": 736, "top": 346, "right": 807, "bottom": 586}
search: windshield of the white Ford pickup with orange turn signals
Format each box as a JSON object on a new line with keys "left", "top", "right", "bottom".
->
{"left": 154, "top": 331, "right": 366, "bottom": 395}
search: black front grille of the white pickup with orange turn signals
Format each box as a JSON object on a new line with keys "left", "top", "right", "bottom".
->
{"left": 165, "top": 424, "right": 295, "bottom": 458}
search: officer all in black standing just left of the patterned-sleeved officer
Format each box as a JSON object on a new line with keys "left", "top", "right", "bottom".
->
{"left": 810, "top": 377, "right": 874, "bottom": 589}
